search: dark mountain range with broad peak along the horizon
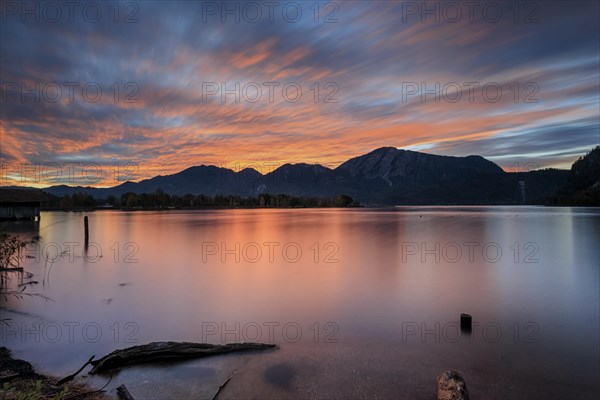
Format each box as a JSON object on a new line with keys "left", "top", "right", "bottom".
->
{"left": 29, "top": 147, "right": 570, "bottom": 205}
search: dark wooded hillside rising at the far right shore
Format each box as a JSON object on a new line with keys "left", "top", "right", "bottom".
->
{"left": 548, "top": 146, "right": 600, "bottom": 207}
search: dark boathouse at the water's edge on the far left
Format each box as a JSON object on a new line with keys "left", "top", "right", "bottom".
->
{"left": 0, "top": 188, "right": 46, "bottom": 220}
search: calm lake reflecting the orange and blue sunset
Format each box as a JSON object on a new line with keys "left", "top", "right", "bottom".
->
{"left": 0, "top": 207, "right": 600, "bottom": 399}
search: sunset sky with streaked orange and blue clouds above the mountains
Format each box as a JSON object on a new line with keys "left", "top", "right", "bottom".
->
{"left": 0, "top": 0, "right": 600, "bottom": 187}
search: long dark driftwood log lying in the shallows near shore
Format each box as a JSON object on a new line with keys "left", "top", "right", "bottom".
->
{"left": 90, "top": 342, "right": 277, "bottom": 374}
